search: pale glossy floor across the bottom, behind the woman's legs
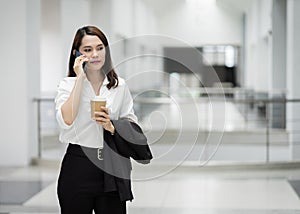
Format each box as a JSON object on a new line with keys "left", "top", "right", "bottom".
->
{"left": 0, "top": 164, "right": 300, "bottom": 214}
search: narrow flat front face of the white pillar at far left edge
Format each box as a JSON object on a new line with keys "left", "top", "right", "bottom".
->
{"left": 0, "top": 0, "right": 28, "bottom": 165}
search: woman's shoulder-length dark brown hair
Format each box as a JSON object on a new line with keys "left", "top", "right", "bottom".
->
{"left": 68, "top": 26, "right": 119, "bottom": 89}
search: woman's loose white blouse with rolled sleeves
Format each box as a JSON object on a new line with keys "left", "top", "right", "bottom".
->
{"left": 55, "top": 77, "right": 137, "bottom": 148}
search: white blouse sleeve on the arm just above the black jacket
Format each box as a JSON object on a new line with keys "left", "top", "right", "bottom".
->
{"left": 120, "top": 84, "right": 138, "bottom": 123}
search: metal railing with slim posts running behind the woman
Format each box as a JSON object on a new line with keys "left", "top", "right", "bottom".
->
{"left": 33, "top": 90, "right": 300, "bottom": 163}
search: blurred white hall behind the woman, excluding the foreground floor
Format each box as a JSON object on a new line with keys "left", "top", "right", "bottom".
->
{"left": 0, "top": 0, "right": 300, "bottom": 213}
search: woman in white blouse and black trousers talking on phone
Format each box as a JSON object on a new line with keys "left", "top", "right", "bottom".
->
{"left": 55, "top": 26, "right": 137, "bottom": 214}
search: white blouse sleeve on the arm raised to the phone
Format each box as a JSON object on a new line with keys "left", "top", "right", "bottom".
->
{"left": 55, "top": 79, "right": 74, "bottom": 129}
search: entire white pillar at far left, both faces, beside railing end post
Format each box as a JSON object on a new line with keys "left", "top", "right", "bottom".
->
{"left": 0, "top": 0, "right": 40, "bottom": 166}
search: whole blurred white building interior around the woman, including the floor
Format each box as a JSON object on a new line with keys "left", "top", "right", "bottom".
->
{"left": 0, "top": 0, "right": 300, "bottom": 214}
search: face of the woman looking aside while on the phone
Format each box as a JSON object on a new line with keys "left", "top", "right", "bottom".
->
{"left": 79, "top": 35, "right": 105, "bottom": 70}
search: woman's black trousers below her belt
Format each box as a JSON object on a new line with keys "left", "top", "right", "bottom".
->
{"left": 57, "top": 144, "right": 126, "bottom": 214}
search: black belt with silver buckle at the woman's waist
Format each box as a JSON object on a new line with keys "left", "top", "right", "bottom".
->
{"left": 67, "top": 143, "right": 103, "bottom": 160}
